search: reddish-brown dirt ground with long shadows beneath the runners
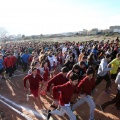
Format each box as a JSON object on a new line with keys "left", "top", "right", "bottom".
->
{"left": 0, "top": 67, "right": 120, "bottom": 120}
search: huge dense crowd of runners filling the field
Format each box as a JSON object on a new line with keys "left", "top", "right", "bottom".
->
{"left": 0, "top": 37, "right": 120, "bottom": 120}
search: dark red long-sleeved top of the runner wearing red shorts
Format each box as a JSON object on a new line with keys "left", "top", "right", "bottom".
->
{"left": 23, "top": 74, "right": 43, "bottom": 90}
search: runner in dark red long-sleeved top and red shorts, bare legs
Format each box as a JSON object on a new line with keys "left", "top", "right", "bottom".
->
{"left": 23, "top": 67, "right": 43, "bottom": 110}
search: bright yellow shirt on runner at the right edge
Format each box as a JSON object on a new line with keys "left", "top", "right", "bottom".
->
{"left": 109, "top": 58, "right": 120, "bottom": 74}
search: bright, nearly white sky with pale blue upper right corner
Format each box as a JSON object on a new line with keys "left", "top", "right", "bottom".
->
{"left": 0, "top": 0, "right": 120, "bottom": 35}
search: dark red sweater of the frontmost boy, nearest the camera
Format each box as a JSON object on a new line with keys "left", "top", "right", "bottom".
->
{"left": 53, "top": 81, "right": 76, "bottom": 106}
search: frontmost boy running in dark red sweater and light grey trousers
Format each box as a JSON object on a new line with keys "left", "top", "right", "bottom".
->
{"left": 47, "top": 73, "right": 78, "bottom": 120}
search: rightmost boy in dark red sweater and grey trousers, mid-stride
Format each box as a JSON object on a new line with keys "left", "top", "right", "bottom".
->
{"left": 72, "top": 67, "right": 95, "bottom": 120}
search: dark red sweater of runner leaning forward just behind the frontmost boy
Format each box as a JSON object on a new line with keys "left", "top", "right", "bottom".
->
{"left": 47, "top": 72, "right": 67, "bottom": 91}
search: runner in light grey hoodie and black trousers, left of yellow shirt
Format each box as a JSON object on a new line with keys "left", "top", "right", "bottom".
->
{"left": 95, "top": 55, "right": 112, "bottom": 93}
